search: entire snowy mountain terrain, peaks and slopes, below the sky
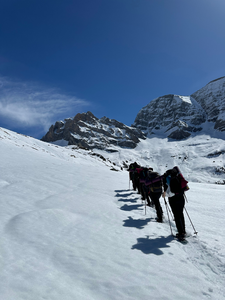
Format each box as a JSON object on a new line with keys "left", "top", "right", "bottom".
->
{"left": 0, "top": 78, "right": 225, "bottom": 300}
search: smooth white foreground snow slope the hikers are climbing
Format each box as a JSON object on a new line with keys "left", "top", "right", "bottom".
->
{"left": 0, "top": 128, "right": 225, "bottom": 300}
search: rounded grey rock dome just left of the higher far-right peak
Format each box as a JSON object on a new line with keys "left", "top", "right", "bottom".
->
{"left": 133, "top": 95, "right": 206, "bottom": 139}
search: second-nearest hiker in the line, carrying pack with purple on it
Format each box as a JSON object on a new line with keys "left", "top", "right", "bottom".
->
{"left": 146, "top": 168, "right": 163, "bottom": 223}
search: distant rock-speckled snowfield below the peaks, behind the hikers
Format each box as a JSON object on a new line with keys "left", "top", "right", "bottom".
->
{"left": 92, "top": 135, "right": 225, "bottom": 184}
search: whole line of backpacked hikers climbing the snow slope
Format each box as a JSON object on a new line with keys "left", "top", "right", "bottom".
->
{"left": 128, "top": 162, "right": 189, "bottom": 241}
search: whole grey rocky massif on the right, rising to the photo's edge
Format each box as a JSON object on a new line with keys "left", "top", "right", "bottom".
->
{"left": 132, "top": 77, "right": 225, "bottom": 140}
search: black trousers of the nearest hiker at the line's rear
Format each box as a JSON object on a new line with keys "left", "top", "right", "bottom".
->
{"left": 169, "top": 194, "right": 186, "bottom": 234}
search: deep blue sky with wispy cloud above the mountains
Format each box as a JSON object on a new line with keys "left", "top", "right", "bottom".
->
{"left": 0, "top": 0, "right": 225, "bottom": 138}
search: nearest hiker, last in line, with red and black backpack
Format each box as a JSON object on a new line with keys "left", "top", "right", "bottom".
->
{"left": 163, "top": 167, "right": 186, "bottom": 239}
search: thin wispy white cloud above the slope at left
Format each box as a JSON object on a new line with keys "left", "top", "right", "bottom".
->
{"left": 0, "top": 77, "right": 90, "bottom": 131}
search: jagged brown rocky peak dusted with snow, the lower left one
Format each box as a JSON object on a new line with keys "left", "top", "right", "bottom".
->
{"left": 42, "top": 112, "right": 145, "bottom": 151}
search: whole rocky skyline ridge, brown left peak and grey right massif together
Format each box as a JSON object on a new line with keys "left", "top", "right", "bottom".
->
{"left": 42, "top": 77, "right": 225, "bottom": 152}
